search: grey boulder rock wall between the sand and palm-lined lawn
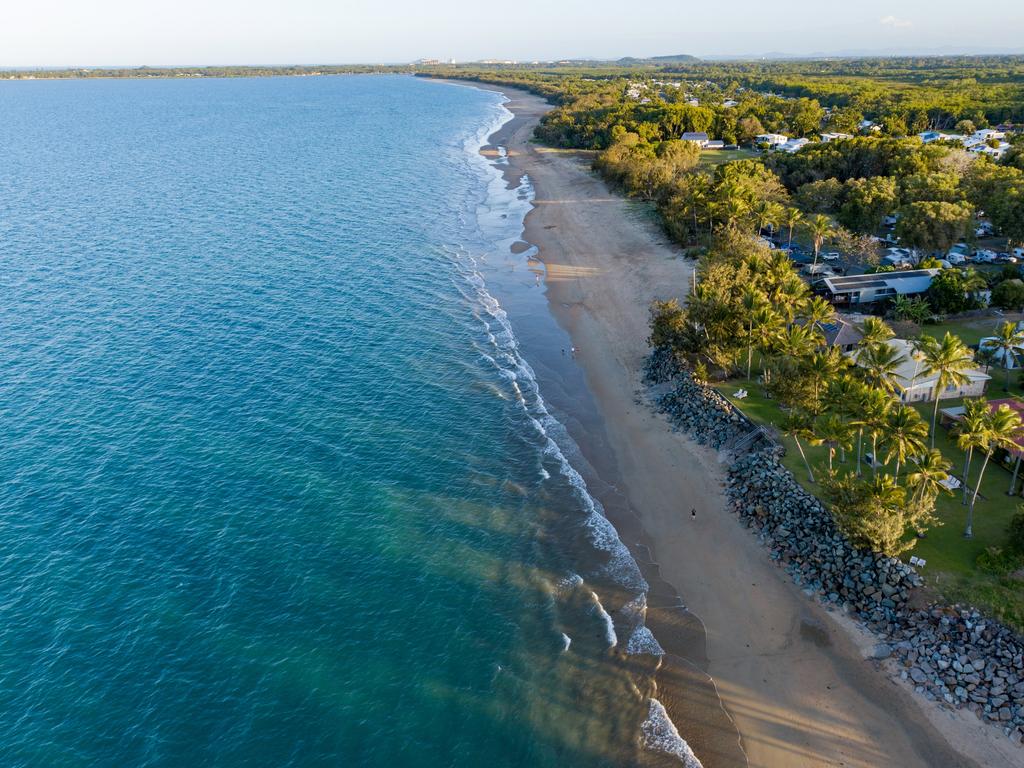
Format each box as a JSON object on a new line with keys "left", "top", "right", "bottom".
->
{"left": 645, "top": 350, "right": 1024, "bottom": 744}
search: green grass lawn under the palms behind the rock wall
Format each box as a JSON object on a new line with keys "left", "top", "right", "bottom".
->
{"left": 717, "top": 380, "right": 1024, "bottom": 629}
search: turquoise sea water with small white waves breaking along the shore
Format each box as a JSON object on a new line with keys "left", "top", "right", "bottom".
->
{"left": 0, "top": 77, "right": 696, "bottom": 768}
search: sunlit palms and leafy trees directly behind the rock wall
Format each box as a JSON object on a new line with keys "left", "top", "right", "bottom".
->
{"left": 651, "top": 237, "right": 1024, "bottom": 627}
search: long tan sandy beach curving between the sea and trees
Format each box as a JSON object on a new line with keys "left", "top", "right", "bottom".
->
{"left": 464, "top": 79, "right": 1022, "bottom": 768}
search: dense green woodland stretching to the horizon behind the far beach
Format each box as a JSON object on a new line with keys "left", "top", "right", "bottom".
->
{"left": 415, "top": 56, "right": 1024, "bottom": 262}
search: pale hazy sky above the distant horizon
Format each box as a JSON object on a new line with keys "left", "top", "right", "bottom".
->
{"left": 0, "top": 0, "right": 1024, "bottom": 67}
